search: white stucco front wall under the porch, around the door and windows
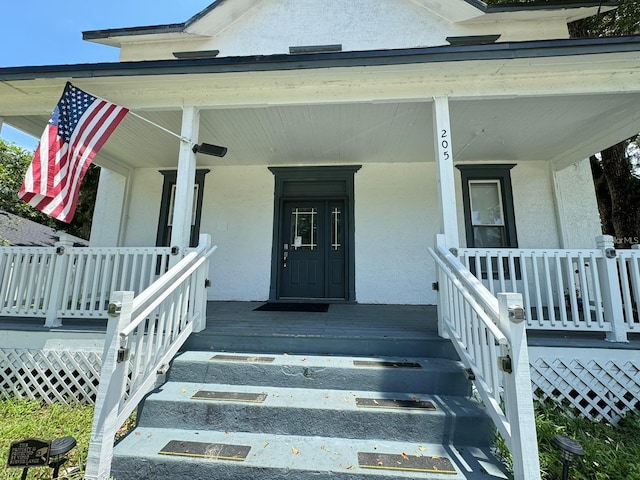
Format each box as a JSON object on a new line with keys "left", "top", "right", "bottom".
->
{"left": 111, "top": 161, "right": 597, "bottom": 304}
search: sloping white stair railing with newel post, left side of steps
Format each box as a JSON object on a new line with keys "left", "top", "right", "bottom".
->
{"left": 84, "top": 235, "right": 216, "bottom": 480}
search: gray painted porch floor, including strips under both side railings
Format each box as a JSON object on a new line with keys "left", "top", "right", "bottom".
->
{"left": 0, "top": 301, "right": 640, "bottom": 350}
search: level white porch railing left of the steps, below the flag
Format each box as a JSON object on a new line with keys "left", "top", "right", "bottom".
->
{"left": 0, "top": 236, "right": 171, "bottom": 327}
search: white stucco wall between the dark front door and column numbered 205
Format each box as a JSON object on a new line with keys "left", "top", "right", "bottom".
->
{"left": 355, "top": 163, "right": 439, "bottom": 304}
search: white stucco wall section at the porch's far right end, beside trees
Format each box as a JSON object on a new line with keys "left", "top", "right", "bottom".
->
{"left": 554, "top": 158, "right": 602, "bottom": 248}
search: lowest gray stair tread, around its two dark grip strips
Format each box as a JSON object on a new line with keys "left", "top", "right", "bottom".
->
{"left": 114, "top": 427, "right": 506, "bottom": 480}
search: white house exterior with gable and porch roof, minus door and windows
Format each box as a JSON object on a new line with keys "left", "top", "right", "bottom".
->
{"left": 0, "top": 0, "right": 638, "bottom": 304}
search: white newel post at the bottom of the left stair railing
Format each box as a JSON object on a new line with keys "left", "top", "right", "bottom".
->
{"left": 84, "top": 292, "right": 133, "bottom": 480}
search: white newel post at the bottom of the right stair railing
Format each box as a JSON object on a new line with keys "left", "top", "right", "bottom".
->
{"left": 498, "top": 293, "right": 540, "bottom": 480}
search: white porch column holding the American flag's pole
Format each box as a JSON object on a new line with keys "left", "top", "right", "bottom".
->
{"left": 171, "top": 107, "right": 200, "bottom": 263}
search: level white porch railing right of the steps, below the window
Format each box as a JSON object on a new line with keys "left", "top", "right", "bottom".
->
{"left": 458, "top": 236, "right": 640, "bottom": 342}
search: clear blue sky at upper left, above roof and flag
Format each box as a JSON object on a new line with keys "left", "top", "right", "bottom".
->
{"left": 0, "top": 0, "right": 213, "bottom": 150}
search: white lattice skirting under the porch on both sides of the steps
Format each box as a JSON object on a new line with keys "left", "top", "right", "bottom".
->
{"left": 0, "top": 347, "right": 640, "bottom": 423}
